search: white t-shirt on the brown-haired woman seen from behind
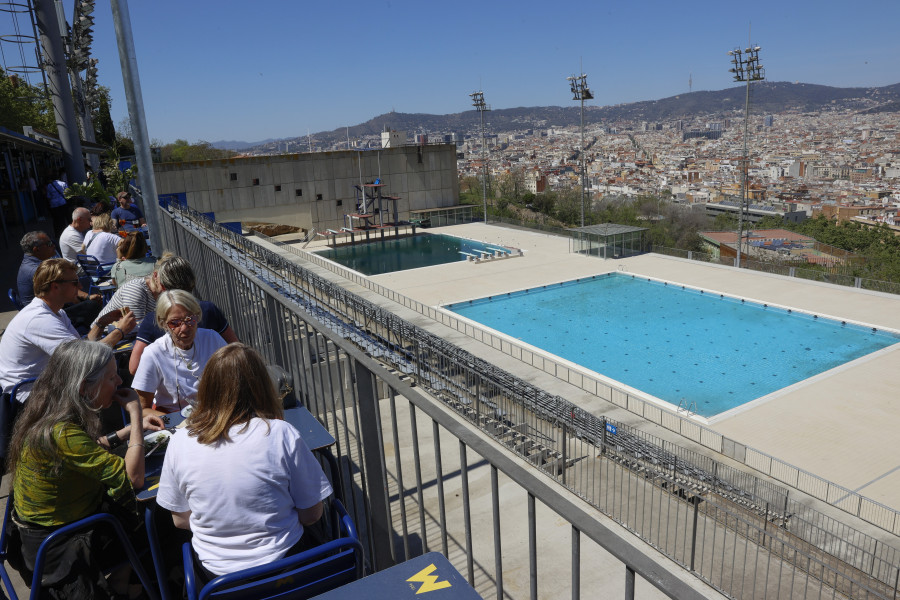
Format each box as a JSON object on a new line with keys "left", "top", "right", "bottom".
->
{"left": 156, "top": 418, "right": 331, "bottom": 575}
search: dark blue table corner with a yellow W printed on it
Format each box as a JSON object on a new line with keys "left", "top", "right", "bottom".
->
{"left": 314, "top": 552, "right": 481, "bottom": 600}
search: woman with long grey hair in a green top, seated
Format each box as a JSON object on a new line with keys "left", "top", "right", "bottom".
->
{"left": 9, "top": 340, "right": 163, "bottom": 597}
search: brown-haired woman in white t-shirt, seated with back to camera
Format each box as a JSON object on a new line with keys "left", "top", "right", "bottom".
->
{"left": 151, "top": 343, "right": 332, "bottom": 576}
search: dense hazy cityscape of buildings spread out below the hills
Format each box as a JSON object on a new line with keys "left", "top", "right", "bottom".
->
{"left": 242, "top": 84, "right": 900, "bottom": 232}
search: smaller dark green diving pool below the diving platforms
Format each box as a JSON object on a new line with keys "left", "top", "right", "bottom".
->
{"left": 317, "top": 233, "right": 511, "bottom": 275}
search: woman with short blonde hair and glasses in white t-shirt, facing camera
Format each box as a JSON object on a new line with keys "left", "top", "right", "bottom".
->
{"left": 131, "top": 290, "right": 226, "bottom": 414}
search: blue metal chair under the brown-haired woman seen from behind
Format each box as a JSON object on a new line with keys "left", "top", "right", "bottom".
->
{"left": 182, "top": 499, "right": 363, "bottom": 600}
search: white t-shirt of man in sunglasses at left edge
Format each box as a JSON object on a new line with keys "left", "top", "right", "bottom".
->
{"left": 0, "top": 298, "right": 81, "bottom": 401}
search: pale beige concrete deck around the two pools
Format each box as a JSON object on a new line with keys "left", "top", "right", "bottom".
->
{"left": 309, "top": 223, "right": 900, "bottom": 509}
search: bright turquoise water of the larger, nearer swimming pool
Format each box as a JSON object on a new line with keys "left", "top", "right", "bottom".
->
{"left": 445, "top": 273, "right": 900, "bottom": 417}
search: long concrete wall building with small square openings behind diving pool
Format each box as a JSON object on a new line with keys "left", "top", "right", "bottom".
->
{"left": 155, "top": 144, "right": 459, "bottom": 231}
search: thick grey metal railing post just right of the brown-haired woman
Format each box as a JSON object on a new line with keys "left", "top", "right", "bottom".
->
{"left": 353, "top": 360, "right": 392, "bottom": 571}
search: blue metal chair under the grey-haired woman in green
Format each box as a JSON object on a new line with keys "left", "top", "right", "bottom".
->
{"left": 0, "top": 494, "right": 156, "bottom": 600}
